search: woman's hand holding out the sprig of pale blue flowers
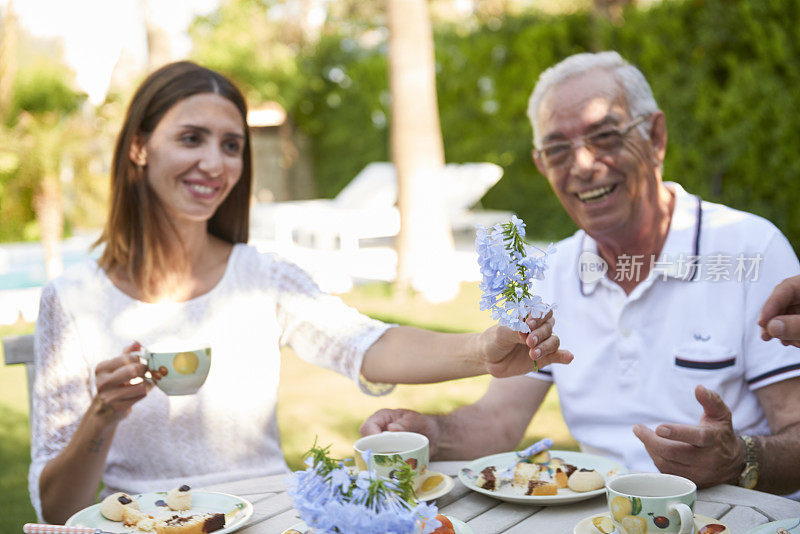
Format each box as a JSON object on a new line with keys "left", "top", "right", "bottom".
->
{"left": 481, "top": 311, "right": 574, "bottom": 378}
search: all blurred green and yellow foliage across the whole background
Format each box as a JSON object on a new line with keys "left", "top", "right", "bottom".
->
{"left": 0, "top": 0, "right": 800, "bottom": 249}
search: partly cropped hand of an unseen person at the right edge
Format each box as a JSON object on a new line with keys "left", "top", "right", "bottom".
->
{"left": 758, "top": 275, "right": 800, "bottom": 347}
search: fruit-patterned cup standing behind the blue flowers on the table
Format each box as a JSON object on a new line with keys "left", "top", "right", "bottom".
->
{"left": 353, "top": 432, "right": 428, "bottom": 489}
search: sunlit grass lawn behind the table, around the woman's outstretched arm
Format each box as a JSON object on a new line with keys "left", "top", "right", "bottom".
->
{"left": 0, "top": 284, "right": 577, "bottom": 533}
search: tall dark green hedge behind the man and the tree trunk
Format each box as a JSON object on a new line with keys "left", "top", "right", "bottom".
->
{"left": 288, "top": 0, "right": 800, "bottom": 249}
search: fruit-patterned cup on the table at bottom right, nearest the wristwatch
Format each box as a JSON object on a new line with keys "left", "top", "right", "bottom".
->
{"left": 598, "top": 473, "right": 697, "bottom": 534}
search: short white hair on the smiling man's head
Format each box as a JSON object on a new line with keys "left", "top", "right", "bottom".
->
{"left": 528, "top": 52, "right": 658, "bottom": 148}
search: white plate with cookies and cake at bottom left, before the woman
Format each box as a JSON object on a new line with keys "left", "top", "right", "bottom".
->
{"left": 65, "top": 490, "right": 253, "bottom": 534}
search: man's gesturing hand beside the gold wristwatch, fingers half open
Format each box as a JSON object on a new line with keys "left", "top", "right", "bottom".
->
{"left": 633, "top": 385, "right": 745, "bottom": 487}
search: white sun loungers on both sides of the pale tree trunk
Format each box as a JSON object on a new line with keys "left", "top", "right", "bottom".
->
{"left": 250, "top": 162, "right": 511, "bottom": 252}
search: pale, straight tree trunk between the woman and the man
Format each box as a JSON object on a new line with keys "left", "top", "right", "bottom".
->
{"left": 387, "top": 0, "right": 458, "bottom": 300}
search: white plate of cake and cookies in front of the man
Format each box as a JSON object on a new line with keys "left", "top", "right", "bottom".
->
{"left": 458, "top": 450, "right": 628, "bottom": 506}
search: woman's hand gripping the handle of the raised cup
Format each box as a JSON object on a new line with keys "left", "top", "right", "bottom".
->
{"left": 92, "top": 343, "right": 153, "bottom": 423}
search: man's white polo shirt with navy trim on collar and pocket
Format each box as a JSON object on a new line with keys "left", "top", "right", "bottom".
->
{"left": 529, "top": 183, "right": 800, "bottom": 471}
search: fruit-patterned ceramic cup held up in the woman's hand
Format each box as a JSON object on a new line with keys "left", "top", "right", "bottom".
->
{"left": 134, "top": 345, "right": 211, "bottom": 395}
